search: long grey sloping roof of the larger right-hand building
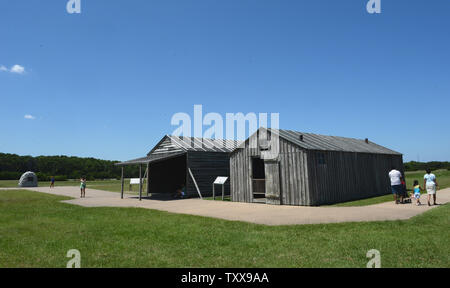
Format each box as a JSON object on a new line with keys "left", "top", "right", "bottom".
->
{"left": 239, "top": 128, "right": 402, "bottom": 155}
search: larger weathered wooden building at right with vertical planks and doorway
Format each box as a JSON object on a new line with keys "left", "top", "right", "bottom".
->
{"left": 230, "top": 128, "right": 403, "bottom": 206}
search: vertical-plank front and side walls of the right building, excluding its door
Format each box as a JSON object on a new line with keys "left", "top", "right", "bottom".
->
{"left": 230, "top": 129, "right": 403, "bottom": 206}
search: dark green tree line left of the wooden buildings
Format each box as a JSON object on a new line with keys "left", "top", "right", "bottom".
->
{"left": 0, "top": 153, "right": 139, "bottom": 181}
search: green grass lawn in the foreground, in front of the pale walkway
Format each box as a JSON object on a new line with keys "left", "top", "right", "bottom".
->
{"left": 0, "top": 190, "right": 450, "bottom": 268}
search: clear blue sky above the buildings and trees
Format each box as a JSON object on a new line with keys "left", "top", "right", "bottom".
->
{"left": 0, "top": 0, "right": 450, "bottom": 161}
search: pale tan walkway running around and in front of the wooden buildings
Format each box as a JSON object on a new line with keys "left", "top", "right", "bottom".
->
{"left": 0, "top": 187, "right": 450, "bottom": 225}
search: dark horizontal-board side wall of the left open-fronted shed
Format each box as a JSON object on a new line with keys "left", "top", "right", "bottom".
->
{"left": 186, "top": 151, "right": 230, "bottom": 197}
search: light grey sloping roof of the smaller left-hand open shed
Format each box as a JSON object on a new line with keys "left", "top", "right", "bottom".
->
{"left": 147, "top": 135, "right": 242, "bottom": 156}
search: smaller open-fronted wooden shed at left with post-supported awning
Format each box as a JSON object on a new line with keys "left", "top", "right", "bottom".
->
{"left": 117, "top": 136, "right": 238, "bottom": 198}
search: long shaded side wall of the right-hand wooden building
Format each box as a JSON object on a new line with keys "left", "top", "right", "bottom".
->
{"left": 307, "top": 151, "right": 403, "bottom": 205}
